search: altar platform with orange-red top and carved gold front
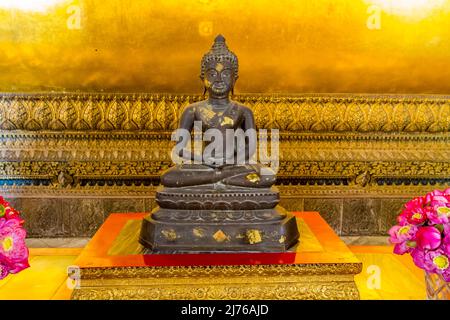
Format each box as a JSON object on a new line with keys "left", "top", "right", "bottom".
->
{"left": 72, "top": 212, "right": 362, "bottom": 300}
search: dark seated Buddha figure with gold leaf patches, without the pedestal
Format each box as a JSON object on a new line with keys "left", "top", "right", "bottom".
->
{"left": 161, "top": 35, "right": 276, "bottom": 188}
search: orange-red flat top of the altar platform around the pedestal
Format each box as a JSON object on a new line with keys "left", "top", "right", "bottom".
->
{"left": 75, "top": 212, "right": 360, "bottom": 269}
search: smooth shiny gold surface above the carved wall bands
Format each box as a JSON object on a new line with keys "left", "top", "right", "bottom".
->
{"left": 0, "top": 0, "right": 450, "bottom": 93}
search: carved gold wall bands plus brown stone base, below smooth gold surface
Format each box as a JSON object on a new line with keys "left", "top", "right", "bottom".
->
{"left": 0, "top": 93, "right": 450, "bottom": 237}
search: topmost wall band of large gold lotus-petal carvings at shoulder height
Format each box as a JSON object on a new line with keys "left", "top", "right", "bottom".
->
{"left": 0, "top": 94, "right": 450, "bottom": 133}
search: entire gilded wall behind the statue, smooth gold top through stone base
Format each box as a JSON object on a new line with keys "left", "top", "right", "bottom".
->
{"left": 0, "top": 0, "right": 450, "bottom": 237}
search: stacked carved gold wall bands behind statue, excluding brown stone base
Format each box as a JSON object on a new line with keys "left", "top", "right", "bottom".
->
{"left": 0, "top": 94, "right": 450, "bottom": 190}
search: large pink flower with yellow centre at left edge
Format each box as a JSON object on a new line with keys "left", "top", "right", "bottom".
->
{"left": 0, "top": 218, "right": 28, "bottom": 264}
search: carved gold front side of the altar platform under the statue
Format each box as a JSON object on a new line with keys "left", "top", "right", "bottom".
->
{"left": 72, "top": 263, "right": 362, "bottom": 300}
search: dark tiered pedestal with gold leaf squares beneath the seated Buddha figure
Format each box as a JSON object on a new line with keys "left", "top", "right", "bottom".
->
{"left": 139, "top": 186, "right": 299, "bottom": 253}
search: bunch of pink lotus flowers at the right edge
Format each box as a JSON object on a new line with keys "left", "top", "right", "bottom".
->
{"left": 389, "top": 188, "right": 450, "bottom": 282}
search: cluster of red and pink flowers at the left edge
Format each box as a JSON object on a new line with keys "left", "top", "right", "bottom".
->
{"left": 0, "top": 196, "right": 30, "bottom": 280}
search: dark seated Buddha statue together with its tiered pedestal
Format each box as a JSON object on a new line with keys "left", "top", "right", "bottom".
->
{"left": 139, "top": 35, "right": 299, "bottom": 254}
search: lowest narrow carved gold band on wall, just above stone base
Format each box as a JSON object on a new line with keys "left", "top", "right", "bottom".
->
{"left": 0, "top": 161, "right": 450, "bottom": 181}
